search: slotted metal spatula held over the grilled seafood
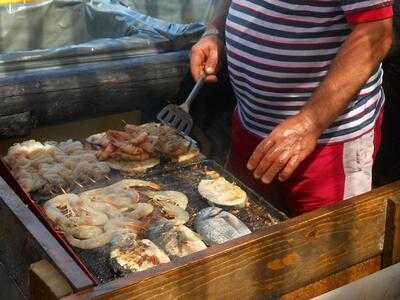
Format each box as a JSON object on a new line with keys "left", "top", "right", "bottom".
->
{"left": 157, "top": 75, "right": 206, "bottom": 135}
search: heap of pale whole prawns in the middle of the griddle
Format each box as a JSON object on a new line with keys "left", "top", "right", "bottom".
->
{"left": 43, "top": 179, "right": 164, "bottom": 249}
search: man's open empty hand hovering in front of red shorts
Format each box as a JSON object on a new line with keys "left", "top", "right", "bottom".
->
{"left": 247, "top": 113, "right": 321, "bottom": 184}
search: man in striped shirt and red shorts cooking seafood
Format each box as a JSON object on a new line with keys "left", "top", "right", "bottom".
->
{"left": 191, "top": 0, "right": 393, "bottom": 215}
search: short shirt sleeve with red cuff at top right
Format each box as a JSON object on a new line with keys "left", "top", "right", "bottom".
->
{"left": 341, "top": 0, "right": 393, "bottom": 25}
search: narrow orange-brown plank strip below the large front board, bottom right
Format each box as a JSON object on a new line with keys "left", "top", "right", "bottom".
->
{"left": 280, "top": 255, "right": 382, "bottom": 300}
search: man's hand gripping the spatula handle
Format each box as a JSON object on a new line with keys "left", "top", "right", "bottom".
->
{"left": 190, "top": 36, "right": 222, "bottom": 82}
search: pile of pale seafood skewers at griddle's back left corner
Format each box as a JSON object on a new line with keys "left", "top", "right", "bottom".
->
{"left": 4, "top": 140, "right": 110, "bottom": 193}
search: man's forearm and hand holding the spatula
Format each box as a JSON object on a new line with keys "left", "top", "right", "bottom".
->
{"left": 190, "top": 0, "right": 231, "bottom": 82}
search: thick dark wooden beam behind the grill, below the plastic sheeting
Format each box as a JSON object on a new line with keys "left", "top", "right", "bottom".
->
{"left": 0, "top": 51, "right": 188, "bottom": 137}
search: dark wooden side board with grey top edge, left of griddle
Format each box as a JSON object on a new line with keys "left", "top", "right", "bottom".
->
{"left": 0, "top": 177, "right": 93, "bottom": 291}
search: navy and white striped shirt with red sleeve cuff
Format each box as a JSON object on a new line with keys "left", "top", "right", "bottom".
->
{"left": 225, "top": 0, "right": 392, "bottom": 143}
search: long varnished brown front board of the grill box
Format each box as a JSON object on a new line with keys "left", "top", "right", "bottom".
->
{"left": 65, "top": 182, "right": 400, "bottom": 300}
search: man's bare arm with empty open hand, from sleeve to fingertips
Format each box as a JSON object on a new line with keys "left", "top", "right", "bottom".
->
{"left": 248, "top": 19, "right": 392, "bottom": 184}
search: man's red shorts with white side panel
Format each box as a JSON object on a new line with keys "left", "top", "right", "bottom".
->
{"left": 228, "top": 113, "right": 383, "bottom": 216}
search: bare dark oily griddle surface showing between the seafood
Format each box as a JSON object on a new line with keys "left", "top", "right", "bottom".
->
{"left": 33, "top": 160, "right": 286, "bottom": 283}
